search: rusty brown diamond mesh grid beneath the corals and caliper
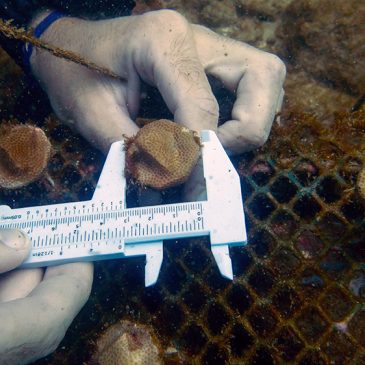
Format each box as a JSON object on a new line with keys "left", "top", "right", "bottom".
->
{"left": 0, "top": 111, "right": 365, "bottom": 365}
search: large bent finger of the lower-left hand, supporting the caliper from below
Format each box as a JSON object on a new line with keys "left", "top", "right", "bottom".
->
{"left": 0, "top": 263, "right": 93, "bottom": 364}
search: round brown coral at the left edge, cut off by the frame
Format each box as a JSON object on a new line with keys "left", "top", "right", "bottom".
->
{"left": 0, "top": 121, "right": 51, "bottom": 189}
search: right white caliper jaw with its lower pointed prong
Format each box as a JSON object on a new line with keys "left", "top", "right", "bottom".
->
{"left": 201, "top": 130, "right": 247, "bottom": 280}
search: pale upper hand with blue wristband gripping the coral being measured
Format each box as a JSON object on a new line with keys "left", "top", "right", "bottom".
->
{"left": 31, "top": 10, "right": 285, "bottom": 196}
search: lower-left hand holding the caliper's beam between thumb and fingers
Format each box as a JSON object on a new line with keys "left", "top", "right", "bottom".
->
{"left": 0, "top": 229, "right": 93, "bottom": 365}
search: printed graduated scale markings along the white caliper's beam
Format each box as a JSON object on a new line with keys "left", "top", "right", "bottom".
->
{"left": 2, "top": 203, "right": 210, "bottom": 260}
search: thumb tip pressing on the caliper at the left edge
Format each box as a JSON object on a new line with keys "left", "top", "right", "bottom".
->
{"left": 0, "top": 229, "right": 30, "bottom": 274}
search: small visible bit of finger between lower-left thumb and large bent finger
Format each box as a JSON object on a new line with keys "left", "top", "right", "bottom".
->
{"left": 0, "top": 268, "right": 43, "bottom": 303}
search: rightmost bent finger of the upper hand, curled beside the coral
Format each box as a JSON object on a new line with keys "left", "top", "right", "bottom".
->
{"left": 194, "top": 26, "right": 285, "bottom": 153}
